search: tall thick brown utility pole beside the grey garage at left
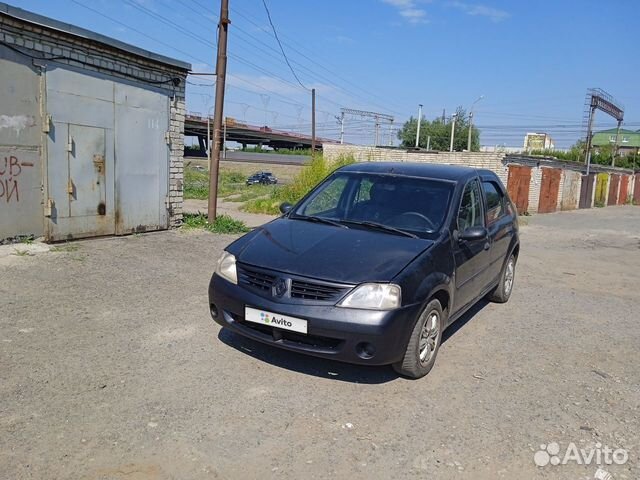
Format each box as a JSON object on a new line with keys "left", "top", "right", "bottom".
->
{"left": 207, "top": 0, "right": 231, "bottom": 223}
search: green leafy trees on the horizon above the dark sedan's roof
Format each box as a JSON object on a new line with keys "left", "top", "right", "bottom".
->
{"left": 398, "top": 107, "right": 480, "bottom": 152}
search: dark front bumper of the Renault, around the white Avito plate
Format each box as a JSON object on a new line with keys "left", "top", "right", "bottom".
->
{"left": 209, "top": 275, "right": 421, "bottom": 365}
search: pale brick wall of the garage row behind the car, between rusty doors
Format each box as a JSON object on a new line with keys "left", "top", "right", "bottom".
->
{"left": 323, "top": 144, "right": 634, "bottom": 213}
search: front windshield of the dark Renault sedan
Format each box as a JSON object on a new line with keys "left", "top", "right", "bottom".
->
{"left": 291, "top": 172, "right": 453, "bottom": 236}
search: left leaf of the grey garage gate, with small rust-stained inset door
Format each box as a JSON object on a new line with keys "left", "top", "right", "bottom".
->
{"left": 45, "top": 68, "right": 115, "bottom": 241}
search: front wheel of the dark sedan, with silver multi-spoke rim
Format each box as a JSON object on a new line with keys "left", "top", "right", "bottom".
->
{"left": 393, "top": 300, "right": 446, "bottom": 378}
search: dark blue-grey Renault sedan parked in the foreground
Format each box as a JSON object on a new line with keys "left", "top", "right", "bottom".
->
{"left": 209, "top": 162, "right": 520, "bottom": 378}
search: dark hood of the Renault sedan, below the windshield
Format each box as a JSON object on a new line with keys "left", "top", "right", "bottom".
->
{"left": 227, "top": 218, "right": 433, "bottom": 284}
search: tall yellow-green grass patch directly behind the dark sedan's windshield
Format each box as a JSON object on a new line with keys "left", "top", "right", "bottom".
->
{"left": 242, "top": 156, "right": 355, "bottom": 215}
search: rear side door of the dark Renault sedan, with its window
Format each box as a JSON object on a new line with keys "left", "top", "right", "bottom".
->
{"left": 482, "top": 179, "right": 514, "bottom": 286}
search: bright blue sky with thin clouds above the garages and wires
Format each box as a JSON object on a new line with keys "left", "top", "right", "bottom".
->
{"left": 9, "top": 0, "right": 640, "bottom": 147}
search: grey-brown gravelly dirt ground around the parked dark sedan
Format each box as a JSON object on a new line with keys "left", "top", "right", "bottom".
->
{"left": 0, "top": 207, "right": 640, "bottom": 480}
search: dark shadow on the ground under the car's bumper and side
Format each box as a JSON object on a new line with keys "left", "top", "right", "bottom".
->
{"left": 218, "top": 300, "right": 489, "bottom": 384}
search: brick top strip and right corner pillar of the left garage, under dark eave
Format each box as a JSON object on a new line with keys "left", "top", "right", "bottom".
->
{"left": 0, "top": 14, "right": 188, "bottom": 226}
